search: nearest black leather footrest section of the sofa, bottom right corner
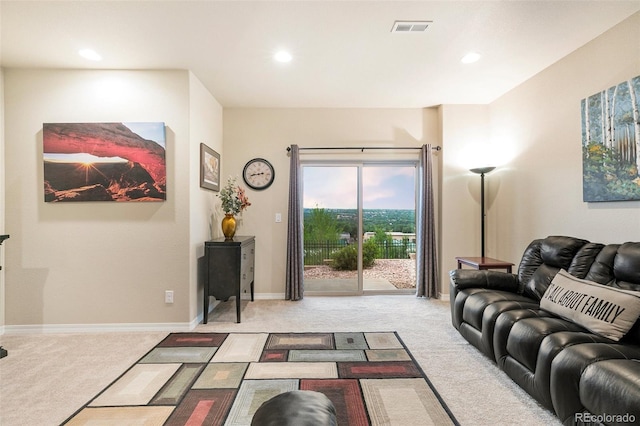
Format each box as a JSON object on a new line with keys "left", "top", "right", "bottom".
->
{"left": 577, "top": 359, "right": 640, "bottom": 425}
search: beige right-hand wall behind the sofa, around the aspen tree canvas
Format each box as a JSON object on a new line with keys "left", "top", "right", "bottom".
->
{"left": 488, "top": 13, "right": 640, "bottom": 262}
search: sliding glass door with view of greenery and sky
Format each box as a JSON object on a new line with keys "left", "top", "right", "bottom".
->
{"left": 302, "top": 163, "right": 416, "bottom": 295}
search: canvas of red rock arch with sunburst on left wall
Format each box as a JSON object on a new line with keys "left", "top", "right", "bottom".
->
{"left": 42, "top": 122, "right": 167, "bottom": 202}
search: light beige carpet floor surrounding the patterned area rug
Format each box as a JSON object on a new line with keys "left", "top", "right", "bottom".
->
{"left": 0, "top": 295, "right": 560, "bottom": 426}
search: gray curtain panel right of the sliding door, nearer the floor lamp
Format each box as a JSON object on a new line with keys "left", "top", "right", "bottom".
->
{"left": 416, "top": 145, "right": 439, "bottom": 297}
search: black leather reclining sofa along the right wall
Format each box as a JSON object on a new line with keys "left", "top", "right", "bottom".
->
{"left": 450, "top": 236, "right": 640, "bottom": 425}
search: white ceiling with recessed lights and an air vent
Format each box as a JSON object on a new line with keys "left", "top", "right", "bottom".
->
{"left": 0, "top": 0, "right": 640, "bottom": 108}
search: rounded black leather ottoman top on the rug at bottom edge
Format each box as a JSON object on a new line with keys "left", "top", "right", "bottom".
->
{"left": 251, "top": 391, "right": 338, "bottom": 426}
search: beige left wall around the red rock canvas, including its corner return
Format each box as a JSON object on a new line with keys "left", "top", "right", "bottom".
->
{"left": 5, "top": 69, "right": 222, "bottom": 329}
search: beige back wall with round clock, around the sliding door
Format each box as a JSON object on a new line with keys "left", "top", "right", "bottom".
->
{"left": 218, "top": 108, "right": 438, "bottom": 298}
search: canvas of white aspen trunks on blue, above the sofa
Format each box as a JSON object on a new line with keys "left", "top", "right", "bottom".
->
{"left": 581, "top": 76, "right": 640, "bottom": 202}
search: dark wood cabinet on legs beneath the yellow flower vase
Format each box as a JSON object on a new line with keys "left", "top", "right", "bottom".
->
{"left": 203, "top": 236, "right": 256, "bottom": 324}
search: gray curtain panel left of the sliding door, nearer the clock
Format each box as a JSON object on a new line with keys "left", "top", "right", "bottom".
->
{"left": 285, "top": 145, "right": 304, "bottom": 300}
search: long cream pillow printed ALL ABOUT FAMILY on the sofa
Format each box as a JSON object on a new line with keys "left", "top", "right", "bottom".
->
{"left": 540, "top": 269, "right": 640, "bottom": 341}
